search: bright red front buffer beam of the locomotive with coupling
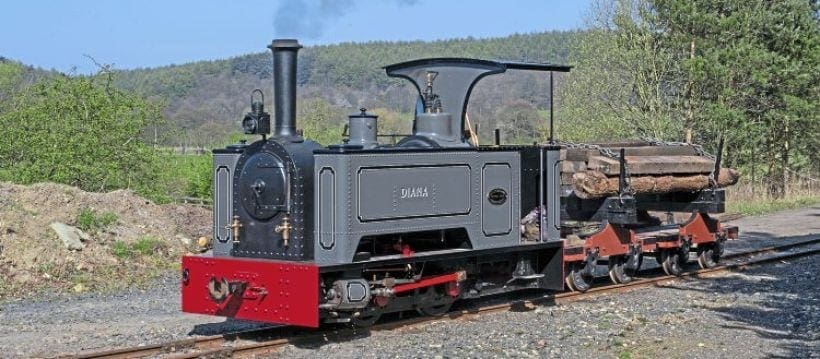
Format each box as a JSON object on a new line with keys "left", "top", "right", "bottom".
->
{"left": 182, "top": 256, "right": 319, "bottom": 328}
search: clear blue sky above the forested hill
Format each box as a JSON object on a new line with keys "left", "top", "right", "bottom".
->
{"left": 0, "top": 0, "right": 590, "bottom": 73}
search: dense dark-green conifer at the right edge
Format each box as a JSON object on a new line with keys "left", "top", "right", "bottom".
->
{"left": 652, "top": 0, "right": 820, "bottom": 197}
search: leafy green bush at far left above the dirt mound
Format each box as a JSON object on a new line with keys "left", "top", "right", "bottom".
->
{"left": 0, "top": 76, "right": 160, "bottom": 191}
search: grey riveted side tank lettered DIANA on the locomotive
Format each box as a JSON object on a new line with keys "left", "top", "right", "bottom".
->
{"left": 314, "top": 150, "right": 521, "bottom": 265}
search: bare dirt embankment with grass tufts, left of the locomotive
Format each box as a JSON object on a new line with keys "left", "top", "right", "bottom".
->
{"left": 0, "top": 183, "right": 211, "bottom": 301}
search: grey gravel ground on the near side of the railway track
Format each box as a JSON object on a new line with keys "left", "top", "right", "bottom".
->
{"left": 279, "top": 250, "right": 820, "bottom": 358}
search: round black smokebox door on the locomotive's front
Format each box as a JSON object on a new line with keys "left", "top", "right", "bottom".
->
{"left": 239, "top": 152, "right": 286, "bottom": 221}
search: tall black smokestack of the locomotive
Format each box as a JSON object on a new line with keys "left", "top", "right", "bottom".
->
{"left": 268, "top": 39, "right": 302, "bottom": 137}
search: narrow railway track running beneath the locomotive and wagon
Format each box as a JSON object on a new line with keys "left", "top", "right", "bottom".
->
{"left": 65, "top": 238, "right": 820, "bottom": 359}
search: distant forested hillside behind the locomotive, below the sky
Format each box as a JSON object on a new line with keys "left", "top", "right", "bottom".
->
{"left": 115, "top": 32, "right": 578, "bottom": 145}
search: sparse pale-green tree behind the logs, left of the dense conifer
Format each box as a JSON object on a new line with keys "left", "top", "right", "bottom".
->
{"left": 556, "top": 0, "right": 681, "bottom": 140}
